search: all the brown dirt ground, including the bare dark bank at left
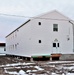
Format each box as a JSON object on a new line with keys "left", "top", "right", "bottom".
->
{"left": 0, "top": 56, "right": 74, "bottom": 75}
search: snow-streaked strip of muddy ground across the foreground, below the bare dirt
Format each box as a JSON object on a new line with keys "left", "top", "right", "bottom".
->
{"left": 0, "top": 61, "right": 74, "bottom": 75}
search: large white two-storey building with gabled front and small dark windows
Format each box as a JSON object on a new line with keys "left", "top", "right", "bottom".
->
{"left": 6, "top": 11, "right": 74, "bottom": 57}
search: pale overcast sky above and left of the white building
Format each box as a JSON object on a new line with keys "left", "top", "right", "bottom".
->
{"left": 0, "top": 0, "right": 74, "bottom": 42}
